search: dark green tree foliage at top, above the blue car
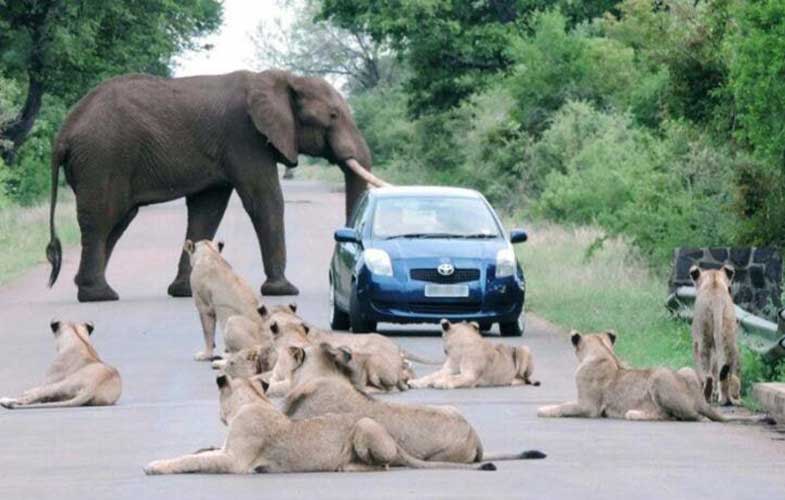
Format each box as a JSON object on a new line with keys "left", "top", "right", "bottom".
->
{"left": 320, "top": 0, "right": 616, "bottom": 116}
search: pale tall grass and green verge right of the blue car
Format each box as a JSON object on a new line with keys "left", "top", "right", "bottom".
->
{"left": 518, "top": 224, "right": 692, "bottom": 368}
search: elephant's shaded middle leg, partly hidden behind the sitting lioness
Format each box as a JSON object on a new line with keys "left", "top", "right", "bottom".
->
{"left": 168, "top": 186, "right": 232, "bottom": 297}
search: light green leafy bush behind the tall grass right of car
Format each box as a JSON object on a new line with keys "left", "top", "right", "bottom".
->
{"left": 531, "top": 102, "right": 742, "bottom": 264}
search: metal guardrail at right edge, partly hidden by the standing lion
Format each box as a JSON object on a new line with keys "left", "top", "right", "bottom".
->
{"left": 665, "top": 286, "right": 785, "bottom": 363}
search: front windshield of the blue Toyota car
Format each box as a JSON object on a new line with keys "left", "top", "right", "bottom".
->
{"left": 372, "top": 196, "right": 499, "bottom": 239}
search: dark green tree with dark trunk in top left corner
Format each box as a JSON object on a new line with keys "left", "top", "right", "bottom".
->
{"left": 0, "top": 0, "right": 222, "bottom": 163}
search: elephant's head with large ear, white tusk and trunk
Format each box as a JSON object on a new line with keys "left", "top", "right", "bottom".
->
{"left": 246, "top": 70, "right": 387, "bottom": 218}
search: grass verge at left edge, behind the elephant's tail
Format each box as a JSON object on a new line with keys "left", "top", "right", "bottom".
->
{"left": 0, "top": 189, "right": 79, "bottom": 285}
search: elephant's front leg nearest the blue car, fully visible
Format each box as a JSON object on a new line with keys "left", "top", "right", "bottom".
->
{"left": 237, "top": 175, "right": 300, "bottom": 295}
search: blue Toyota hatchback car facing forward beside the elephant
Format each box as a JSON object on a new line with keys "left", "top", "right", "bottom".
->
{"left": 329, "top": 187, "right": 526, "bottom": 336}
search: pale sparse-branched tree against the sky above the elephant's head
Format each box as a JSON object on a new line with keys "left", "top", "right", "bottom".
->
{"left": 253, "top": 0, "right": 396, "bottom": 90}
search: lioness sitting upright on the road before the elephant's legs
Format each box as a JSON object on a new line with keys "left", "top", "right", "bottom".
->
{"left": 183, "top": 240, "right": 262, "bottom": 361}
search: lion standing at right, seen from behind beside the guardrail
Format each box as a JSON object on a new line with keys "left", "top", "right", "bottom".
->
{"left": 690, "top": 264, "right": 741, "bottom": 406}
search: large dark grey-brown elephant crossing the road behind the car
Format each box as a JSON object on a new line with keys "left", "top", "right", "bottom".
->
{"left": 46, "top": 70, "right": 386, "bottom": 302}
